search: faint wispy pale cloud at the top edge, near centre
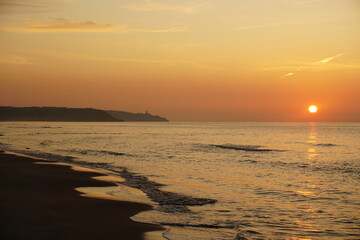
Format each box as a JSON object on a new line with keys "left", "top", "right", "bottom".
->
{"left": 125, "top": 1, "right": 195, "bottom": 13}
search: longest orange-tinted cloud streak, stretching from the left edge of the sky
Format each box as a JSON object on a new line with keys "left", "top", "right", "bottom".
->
{"left": 0, "top": 18, "right": 187, "bottom": 33}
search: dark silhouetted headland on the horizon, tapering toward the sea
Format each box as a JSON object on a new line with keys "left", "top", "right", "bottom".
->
{"left": 0, "top": 106, "right": 169, "bottom": 122}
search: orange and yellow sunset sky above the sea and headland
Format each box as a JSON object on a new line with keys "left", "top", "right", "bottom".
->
{"left": 0, "top": 0, "right": 360, "bottom": 122}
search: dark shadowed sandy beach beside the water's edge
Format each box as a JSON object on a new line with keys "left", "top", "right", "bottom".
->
{"left": 0, "top": 151, "right": 164, "bottom": 240}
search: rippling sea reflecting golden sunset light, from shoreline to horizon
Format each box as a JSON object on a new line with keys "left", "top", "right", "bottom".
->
{"left": 0, "top": 122, "right": 360, "bottom": 240}
